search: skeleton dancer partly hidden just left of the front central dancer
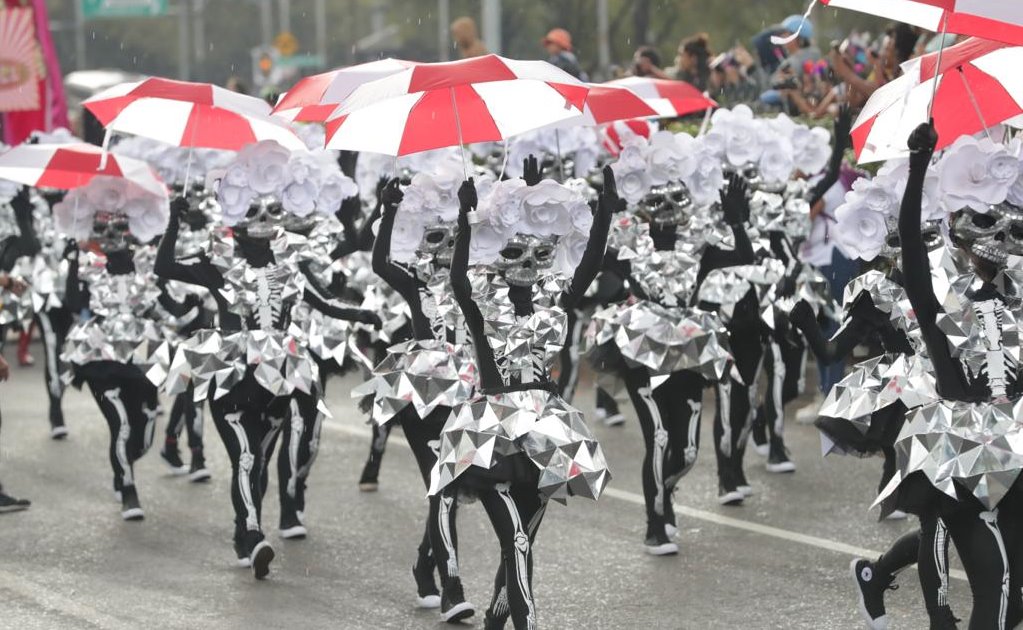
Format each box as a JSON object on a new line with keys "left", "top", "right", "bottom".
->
{"left": 353, "top": 165, "right": 476, "bottom": 623}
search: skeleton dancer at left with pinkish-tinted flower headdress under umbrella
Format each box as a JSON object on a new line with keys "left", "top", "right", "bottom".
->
{"left": 54, "top": 177, "right": 172, "bottom": 521}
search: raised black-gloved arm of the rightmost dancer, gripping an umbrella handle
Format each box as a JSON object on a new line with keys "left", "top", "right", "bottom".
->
{"left": 898, "top": 123, "right": 967, "bottom": 400}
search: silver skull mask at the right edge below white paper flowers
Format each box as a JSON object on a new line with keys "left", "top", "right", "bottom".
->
{"left": 949, "top": 201, "right": 1023, "bottom": 267}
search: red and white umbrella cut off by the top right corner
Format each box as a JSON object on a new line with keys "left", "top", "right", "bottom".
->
{"left": 811, "top": 0, "right": 1023, "bottom": 46}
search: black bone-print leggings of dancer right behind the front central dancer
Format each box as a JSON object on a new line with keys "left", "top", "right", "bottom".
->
{"left": 625, "top": 367, "right": 704, "bottom": 536}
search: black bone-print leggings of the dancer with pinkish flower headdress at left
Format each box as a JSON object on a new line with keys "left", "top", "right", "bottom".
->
{"left": 85, "top": 364, "right": 160, "bottom": 492}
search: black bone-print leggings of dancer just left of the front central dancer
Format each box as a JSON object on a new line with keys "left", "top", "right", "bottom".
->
{"left": 396, "top": 405, "right": 458, "bottom": 587}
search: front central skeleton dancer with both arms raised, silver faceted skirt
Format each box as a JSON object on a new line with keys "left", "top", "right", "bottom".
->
{"left": 431, "top": 168, "right": 620, "bottom": 628}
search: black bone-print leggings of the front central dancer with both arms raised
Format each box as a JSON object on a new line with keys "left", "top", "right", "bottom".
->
{"left": 466, "top": 473, "right": 547, "bottom": 630}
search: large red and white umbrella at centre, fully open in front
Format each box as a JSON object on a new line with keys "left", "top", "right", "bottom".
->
{"left": 326, "top": 54, "right": 589, "bottom": 155}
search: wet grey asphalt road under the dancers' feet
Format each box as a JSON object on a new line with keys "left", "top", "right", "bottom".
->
{"left": 0, "top": 348, "right": 969, "bottom": 630}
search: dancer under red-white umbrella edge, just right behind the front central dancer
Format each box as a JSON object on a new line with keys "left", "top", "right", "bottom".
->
{"left": 587, "top": 176, "right": 749, "bottom": 555}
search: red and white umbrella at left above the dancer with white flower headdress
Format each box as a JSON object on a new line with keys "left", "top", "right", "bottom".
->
{"left": 82, "top": 77, "right": 306, "bottom": 150}
